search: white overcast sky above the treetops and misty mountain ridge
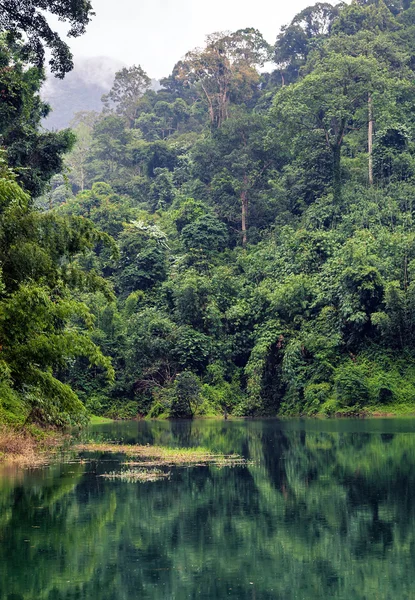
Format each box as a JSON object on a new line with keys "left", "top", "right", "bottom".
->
{"left": 59, "top": 0, "right": 342, "bottom": 79}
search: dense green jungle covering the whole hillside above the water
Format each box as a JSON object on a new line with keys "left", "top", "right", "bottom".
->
{"left": 0, "top": 0, "right": 415, "bottom": 424}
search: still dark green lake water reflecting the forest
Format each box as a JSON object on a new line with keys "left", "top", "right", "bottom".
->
{"left": 0, "top": 419, "right": 415, "bottom": 600}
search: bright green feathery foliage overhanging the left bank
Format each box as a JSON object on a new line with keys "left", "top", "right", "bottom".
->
{"left": 0, "top": 155, "right": 113, "bottom": 425}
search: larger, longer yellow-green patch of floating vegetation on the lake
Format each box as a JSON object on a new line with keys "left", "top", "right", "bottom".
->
{"left": 76, "top": 443, "right": 247, "bottom": 468}
